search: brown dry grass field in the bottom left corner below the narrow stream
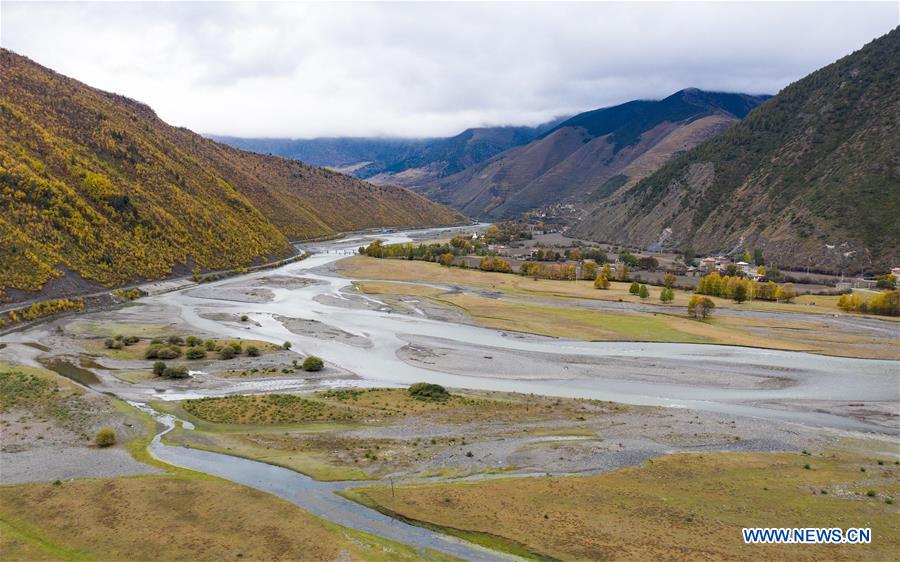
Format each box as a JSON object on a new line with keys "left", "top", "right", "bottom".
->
{"left": 0, "top": 476, "right": 454, "bottom": 562}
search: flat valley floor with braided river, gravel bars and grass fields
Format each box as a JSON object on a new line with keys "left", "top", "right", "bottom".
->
{"left": 0, "top": 225, "right": 900, "bottom": 560}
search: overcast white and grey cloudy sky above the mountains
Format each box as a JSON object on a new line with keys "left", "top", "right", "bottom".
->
{"left": 0, "top": 1, "right": 898, "bottom": 137}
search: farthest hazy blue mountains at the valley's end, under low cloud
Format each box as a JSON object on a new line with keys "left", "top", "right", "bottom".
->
{"left": 210, "top": 119, "right": 560, "bottom": 186}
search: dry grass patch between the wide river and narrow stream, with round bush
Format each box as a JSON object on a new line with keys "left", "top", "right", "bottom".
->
{"left": 154, "top": 389, "right": 628, "bottom": 480}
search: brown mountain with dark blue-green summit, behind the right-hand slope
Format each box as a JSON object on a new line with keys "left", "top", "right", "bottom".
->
{"left": 417, "top": 89, "right": 766, "bottom": 218}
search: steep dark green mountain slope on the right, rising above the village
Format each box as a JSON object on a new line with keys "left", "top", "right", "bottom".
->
{"left": 575, "top": 28, "right": 900, "bottom": 272}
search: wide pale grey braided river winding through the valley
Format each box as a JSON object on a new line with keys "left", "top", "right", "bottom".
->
{"left": 134, "top": 224, "right": 900, "bottom": 433}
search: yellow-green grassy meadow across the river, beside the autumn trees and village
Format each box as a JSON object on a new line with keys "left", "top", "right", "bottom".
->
{"left": 338, "top": 256, "right": 900, "bottom": 359}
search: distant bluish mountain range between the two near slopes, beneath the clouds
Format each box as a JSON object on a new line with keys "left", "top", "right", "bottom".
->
{"left": 213, "top": 89, "right": 766, "bottom": 220}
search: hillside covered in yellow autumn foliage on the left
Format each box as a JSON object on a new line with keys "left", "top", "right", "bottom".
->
{"left": 0, "top": 50, "right": 461, "bottom": 300}
